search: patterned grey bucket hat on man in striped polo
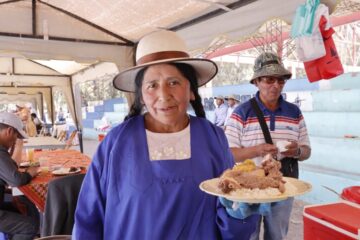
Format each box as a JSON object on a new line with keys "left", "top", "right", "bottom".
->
{"left": 250, "top": 52, "right": 291, "bottom": 84}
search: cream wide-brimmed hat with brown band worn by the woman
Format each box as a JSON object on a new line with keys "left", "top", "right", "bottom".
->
{"left": 113, "top": 30, "right": 218, "bottom": 92}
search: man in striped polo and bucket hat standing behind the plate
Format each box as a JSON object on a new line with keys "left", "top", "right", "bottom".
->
{"left": 225, "top": 52, "right": 311, "bottom": 240}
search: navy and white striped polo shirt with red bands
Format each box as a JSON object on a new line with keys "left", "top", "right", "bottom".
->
{"left": 225, "top": 92, "right": 310, "bottom": 165}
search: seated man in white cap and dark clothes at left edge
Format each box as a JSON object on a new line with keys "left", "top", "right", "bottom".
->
{"left": 0, "top": 112, "right": 38, "bottom": 239}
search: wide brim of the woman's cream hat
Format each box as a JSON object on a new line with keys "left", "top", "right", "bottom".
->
{"left": 113, "top": 58, "right": 218, "bottom": 92}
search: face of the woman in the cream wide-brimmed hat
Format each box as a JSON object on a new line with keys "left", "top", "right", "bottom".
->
{"left": 141, "top": 64, "right": 195, "bottom": 132}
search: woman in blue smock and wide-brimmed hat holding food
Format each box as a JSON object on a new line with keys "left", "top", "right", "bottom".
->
{"left": 73, "top": 30, "right": 259, "bottom": 239}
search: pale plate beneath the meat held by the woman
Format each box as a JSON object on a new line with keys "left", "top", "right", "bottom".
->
{"left": 199, "top": 177, "right": 312, "bottom": 203}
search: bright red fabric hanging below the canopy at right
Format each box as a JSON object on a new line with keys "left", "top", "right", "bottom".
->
{"left": 304, "top": 16, "right": 344, "bottom": 82}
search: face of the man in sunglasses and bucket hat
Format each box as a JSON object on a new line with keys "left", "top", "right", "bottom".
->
{"left": 255, "top": 76, "right": 286, "bottom": 103}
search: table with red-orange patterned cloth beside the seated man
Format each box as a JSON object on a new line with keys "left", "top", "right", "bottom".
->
{"left": 19, "top": 150, "right": 91, "bottom": 212}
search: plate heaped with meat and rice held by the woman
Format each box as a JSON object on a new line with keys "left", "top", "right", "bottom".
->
{"left": 199, "top": 159, "right": 312, "bottom": 203}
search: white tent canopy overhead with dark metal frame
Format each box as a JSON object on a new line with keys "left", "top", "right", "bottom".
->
{"left": 0, "top": 0, "right": 352, "bottom": 136}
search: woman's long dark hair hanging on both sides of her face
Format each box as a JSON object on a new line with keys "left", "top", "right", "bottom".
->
{"left": 125, "top": 63, "right": 206, "bottom": 120}
